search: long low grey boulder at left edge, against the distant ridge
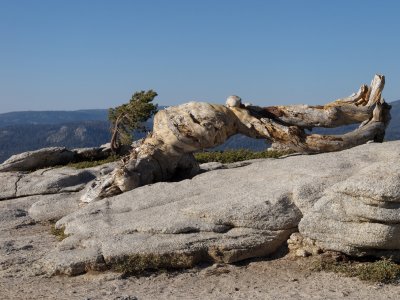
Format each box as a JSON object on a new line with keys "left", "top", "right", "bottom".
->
{"left": 0, "top": 147, "right": 75, "bottom": 172}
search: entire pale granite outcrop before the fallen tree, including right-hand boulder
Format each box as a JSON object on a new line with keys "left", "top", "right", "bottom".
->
{"left": 30, "top": 142, "right": 400, "bottom": 275}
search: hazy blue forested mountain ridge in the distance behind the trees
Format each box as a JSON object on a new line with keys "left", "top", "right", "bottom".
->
{"left": 0, "top": 100, "right": 400, "bottom": 163}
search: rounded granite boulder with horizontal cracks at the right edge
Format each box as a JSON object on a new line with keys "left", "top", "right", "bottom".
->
{"left": 299, "top": 158, "right": 400, "bottom": 260}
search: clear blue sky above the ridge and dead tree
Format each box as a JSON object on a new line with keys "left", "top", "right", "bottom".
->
{"left": 0, "top": 0, "right": 400, "bottom": 113}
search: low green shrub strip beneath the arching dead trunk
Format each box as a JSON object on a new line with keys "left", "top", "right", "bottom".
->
{"left": 194, "top": 149, "right": 293, "bottom": 164}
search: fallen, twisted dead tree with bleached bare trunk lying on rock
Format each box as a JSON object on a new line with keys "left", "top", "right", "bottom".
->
{"left": 82, "top": 75, "right": 390, "bottom": 202}
